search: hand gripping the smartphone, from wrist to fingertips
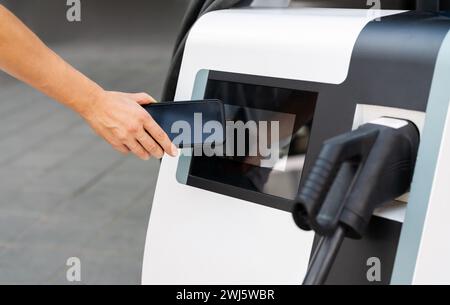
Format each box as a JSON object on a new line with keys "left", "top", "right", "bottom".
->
{"left": 79, "top": 91, "right": 178, "bottom": 160}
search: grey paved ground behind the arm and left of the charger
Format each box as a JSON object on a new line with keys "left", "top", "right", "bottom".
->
{"left": 0, "top": 1, "right": 187, "bottom": 284}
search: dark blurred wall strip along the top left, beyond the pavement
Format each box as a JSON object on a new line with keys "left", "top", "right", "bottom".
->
{"left": 4, "top": 0, "right": 188, "bottom": 42}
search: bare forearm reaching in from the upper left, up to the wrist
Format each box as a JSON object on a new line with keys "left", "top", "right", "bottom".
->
{"left": 0, "top": 5, "right": 103, "bottom": 114}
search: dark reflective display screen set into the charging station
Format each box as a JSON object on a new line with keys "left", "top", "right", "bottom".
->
{"left": 187, "top": 75, "right": 317, "bottom": 209}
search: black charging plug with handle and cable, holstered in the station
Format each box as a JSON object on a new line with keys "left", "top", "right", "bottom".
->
{"left": 293, "top": 118, "right": 419, "bottom": 285}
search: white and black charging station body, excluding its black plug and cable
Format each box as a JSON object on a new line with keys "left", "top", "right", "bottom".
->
{"left": 142, "top": 8, "right": 450, "bottom": 284}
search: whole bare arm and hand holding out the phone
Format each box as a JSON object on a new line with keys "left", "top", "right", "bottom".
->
{"left": 0, "top": 5, "right": 177, "bottom": 160}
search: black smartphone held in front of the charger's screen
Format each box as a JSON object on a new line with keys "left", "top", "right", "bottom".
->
{"left": 143, "top": 100, "right": 225, "bottom": 148}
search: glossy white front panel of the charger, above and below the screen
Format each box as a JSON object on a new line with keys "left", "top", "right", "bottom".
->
{"left": 142, "top": 9, "right": 397, "bottom": 284}
